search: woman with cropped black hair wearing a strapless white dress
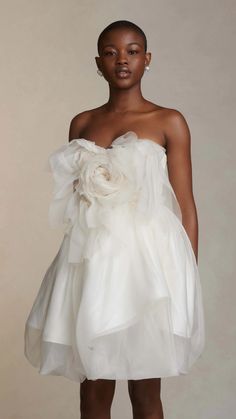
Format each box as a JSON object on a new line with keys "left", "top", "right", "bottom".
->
{"left": 25, "top": 20, "right": 204, "bottom": 419}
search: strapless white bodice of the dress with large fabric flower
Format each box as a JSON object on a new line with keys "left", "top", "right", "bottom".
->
{"left": 48, "top": 131, "right": 182, "bottom": 262}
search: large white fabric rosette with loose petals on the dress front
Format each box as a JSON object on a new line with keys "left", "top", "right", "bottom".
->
{"left": 49, "top": 139, "right": 139, "bottom": 263}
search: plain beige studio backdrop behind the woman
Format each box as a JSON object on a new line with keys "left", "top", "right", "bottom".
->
{"left": 0, "top": 0, "right": 236, "bottom": 419}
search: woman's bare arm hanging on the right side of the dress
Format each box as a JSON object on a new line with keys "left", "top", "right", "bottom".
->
{"left": 165, "top": 109, "right": 198, "bottom": 260}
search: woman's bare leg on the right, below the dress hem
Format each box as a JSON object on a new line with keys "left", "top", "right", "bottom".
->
{"left": 128, "top": 378, "right": 164, "bottom": 419}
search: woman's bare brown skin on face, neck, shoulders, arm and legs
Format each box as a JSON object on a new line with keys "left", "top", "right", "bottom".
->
{"left": 69, "top": 28, "right": 198, "bottom": 419}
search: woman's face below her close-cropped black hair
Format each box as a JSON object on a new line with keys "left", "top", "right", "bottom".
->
{"left": 95, "top": 28, "right": 151, "bottom": 88}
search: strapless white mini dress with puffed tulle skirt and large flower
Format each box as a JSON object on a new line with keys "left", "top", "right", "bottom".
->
{"left": 25, "top": 131, "right": 205, "bottom": 382}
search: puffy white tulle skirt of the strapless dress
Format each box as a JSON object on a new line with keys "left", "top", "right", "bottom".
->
{"left": 25, "top": 206, "right": 205, "bottom": 382}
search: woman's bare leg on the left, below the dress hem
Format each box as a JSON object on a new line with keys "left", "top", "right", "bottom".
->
{"left": 80, "top": 378, "right": 116, "bottom": 419}
